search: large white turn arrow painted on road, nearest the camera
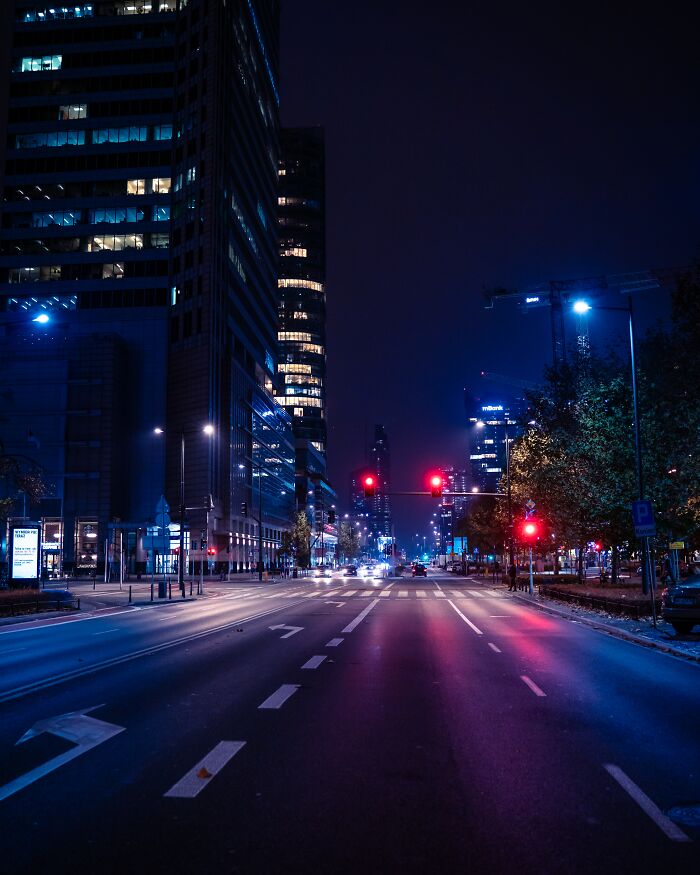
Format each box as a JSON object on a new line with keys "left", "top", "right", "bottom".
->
{"left": 0, "top": 705, "right": 125, "bottom": 801}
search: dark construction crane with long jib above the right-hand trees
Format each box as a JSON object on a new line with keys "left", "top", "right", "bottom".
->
{"left": 484, "top": 268, "right": 687, "bottom": 367}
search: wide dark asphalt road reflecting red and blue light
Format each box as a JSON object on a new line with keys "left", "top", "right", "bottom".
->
{"left": 0, "top": 574, "right": 700, "bottom": 875}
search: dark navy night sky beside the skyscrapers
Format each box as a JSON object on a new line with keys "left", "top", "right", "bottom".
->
{"left": 281, "top": 0, "right": 700, "bottom": 539}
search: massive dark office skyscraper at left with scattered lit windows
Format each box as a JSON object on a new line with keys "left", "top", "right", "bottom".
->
{"left": 0, "top": 0, "right": 294, "bottom": 570}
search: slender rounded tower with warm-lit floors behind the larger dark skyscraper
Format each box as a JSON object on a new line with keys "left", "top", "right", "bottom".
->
{"left": 278, "top": 128, "right": 327, "bottom": 456}
